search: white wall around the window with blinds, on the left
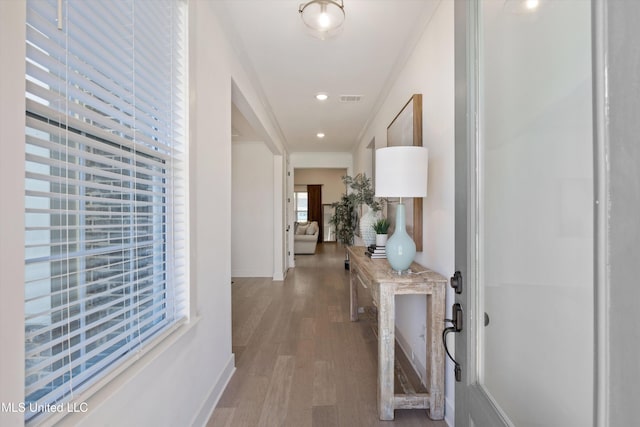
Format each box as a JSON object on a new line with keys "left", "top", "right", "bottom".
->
{"left": 0, "top": 0, "right": 284, "bottom": 426}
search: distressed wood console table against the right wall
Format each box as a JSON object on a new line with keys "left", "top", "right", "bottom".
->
{"left": 348, "top": 246, "right": 447, "bottom": 420}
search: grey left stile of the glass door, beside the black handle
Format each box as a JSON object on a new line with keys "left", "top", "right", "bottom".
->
{"left": 454, "top": 1, "right": 509, "bottom": 427}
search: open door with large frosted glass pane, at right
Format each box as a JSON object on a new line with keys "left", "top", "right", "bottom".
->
{"left": 456, "top": 0, "right": 594, "bottom": 427}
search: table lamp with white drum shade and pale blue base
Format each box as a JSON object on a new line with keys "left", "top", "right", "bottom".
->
{"left": 375, "top": 146, "right": 429, "bottom": 274}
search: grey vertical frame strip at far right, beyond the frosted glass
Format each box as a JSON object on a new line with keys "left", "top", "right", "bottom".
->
{"left": 592, "top": 0, "right": 640, "bottom": 427}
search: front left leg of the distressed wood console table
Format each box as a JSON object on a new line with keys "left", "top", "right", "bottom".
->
{"left": 378, "top": 286, "right": 395, "bottom": 420}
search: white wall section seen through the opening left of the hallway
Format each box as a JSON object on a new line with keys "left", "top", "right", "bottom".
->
{"left": 231, "top": 142, "right": 274, "bottom": 277}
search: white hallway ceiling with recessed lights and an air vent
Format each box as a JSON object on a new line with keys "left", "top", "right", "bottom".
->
{"left": 218, "top": 0, "right": 441, "bottom": 153}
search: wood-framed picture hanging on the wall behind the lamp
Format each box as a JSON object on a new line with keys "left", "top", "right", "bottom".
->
{"left": 387, "top": 93, "right": 422, "bottom": 252}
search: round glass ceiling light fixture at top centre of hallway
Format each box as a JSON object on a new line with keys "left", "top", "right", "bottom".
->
{"left": 298, "top": 0, "right": 345, "bottom": 40}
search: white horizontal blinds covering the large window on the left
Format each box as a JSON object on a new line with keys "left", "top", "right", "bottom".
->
{"left": 25, "top": 0, "right": 188, "bottom": 420}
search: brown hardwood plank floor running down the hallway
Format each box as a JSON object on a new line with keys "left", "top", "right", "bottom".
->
{"left": 207, "top": 244, "right": 446, "bottom": 427}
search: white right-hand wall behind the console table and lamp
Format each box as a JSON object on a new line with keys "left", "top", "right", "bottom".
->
{"left": 354, "top": 1, "right": 455, "bottom": 425}
